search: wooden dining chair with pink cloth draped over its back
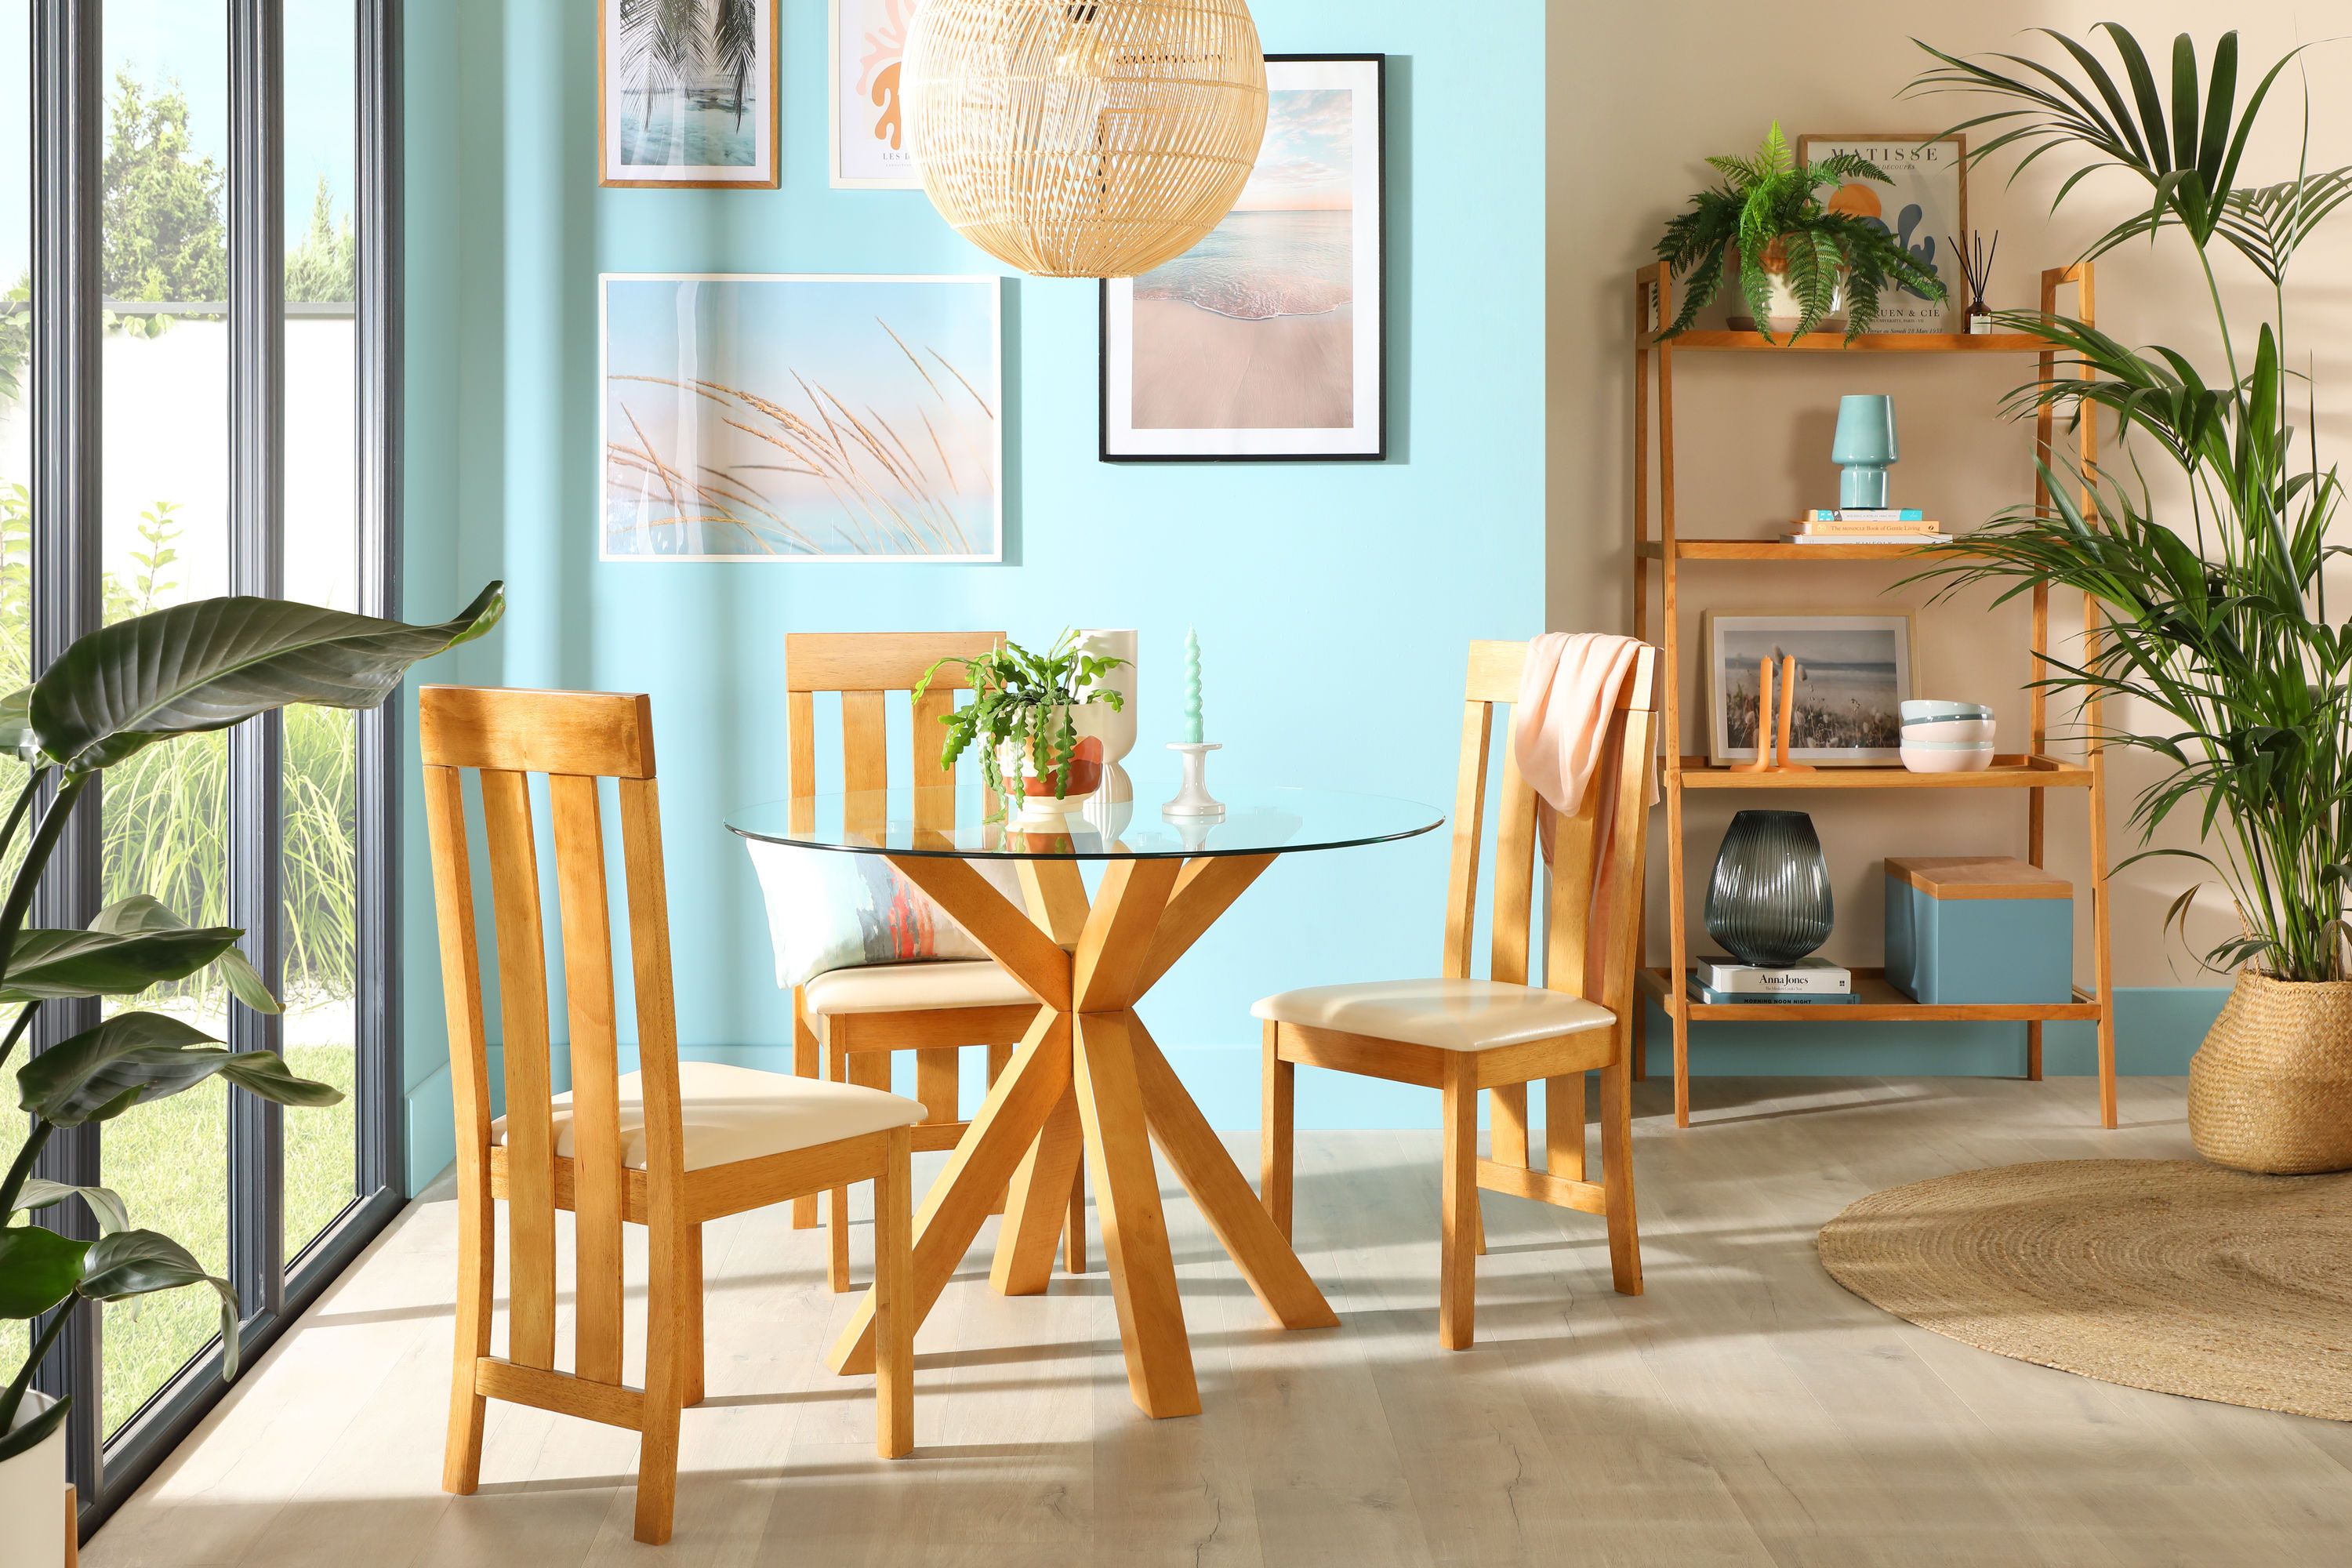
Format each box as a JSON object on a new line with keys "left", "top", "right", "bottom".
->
{"left": 1251, "top": 642, "right": 1658, "bottom": 1349}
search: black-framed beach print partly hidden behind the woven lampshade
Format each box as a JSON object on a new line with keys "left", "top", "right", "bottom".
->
{"left": 1101, "top": 54, "right": 1388, "bottom": 463}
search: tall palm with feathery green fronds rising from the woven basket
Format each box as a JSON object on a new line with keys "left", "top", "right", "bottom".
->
{"left": 1910, "top": 24, "right": 2352, "bottom": 980}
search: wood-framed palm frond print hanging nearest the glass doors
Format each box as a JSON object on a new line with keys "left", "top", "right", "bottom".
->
{"left": 595, "top": 0, "right": 783, "bottom": 191}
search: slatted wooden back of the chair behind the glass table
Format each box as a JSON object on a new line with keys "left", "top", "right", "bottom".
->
{"left": 783, "top": 633, "right": 1004, "bottom": 829}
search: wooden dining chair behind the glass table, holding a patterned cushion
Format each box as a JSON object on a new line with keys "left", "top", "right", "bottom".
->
{"left": 783, "top": 633, "right": 1087, "bottom": 1290}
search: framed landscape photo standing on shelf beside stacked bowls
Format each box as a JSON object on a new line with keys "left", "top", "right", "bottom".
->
{"left": 1700, "top": 609, "right": 1912, "bottom": 767}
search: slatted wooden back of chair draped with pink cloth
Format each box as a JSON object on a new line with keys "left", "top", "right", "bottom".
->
{"left": 1444, "top": 642, "right": 1658, "bottom": 1018}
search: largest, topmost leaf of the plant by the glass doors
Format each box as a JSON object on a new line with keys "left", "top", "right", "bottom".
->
{"left": 31, "top": 583, "right": 506, "bottom": 774}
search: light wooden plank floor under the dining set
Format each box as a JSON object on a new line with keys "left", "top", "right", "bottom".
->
{"left": 82, "top": 1074, "right": 2352, "bottom": 1568}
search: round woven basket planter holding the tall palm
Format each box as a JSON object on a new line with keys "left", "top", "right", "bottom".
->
{"left": 2190, "top": 971, "right": 2352, "bottom": 1175}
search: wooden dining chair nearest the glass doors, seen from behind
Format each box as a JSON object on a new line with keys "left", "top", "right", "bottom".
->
{"left": 419, "top": 687, "right": 922, "bottom": 1542}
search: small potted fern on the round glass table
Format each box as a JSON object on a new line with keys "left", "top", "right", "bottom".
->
{"left": 915, "top": 633, "right": 1127, "bottom": 815}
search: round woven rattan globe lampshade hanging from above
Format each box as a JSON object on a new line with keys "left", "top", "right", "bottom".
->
{"left": 901, "top": 0, "right": 1265, "bottom": 278}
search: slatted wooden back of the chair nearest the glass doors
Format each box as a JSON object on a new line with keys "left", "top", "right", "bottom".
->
{"left": 419, "top": 687, "right": 684, "bottom": 1385}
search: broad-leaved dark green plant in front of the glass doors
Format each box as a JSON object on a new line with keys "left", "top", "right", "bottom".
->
{"left": 0, "top": 583, "right": 503, "bottom": 1460}
